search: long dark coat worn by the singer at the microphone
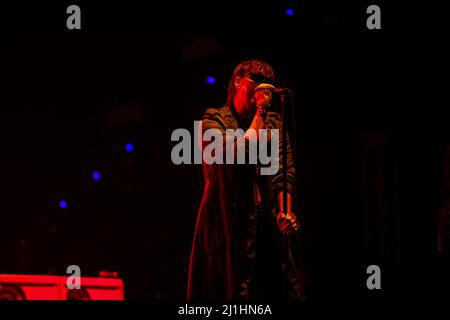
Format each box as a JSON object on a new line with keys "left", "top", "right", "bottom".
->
{"left": 187, "top": 106, "right": 303, "bottom": 301}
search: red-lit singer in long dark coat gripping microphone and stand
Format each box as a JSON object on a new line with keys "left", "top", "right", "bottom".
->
{"left": 187, "top": 60, "right": 303, "bottom": 301}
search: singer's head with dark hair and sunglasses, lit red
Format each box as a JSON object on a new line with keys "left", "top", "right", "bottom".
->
{"left": 227, "top": 60, "right": 275, "bottom": 119}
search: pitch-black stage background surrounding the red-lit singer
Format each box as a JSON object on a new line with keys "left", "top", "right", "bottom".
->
{"left": 0, "top": 0, "right": 444, "bottom": 299}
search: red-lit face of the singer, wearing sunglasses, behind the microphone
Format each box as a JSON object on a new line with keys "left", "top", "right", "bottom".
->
{"left": 234, "top": 73, "right": 272, "bottom": 118}
